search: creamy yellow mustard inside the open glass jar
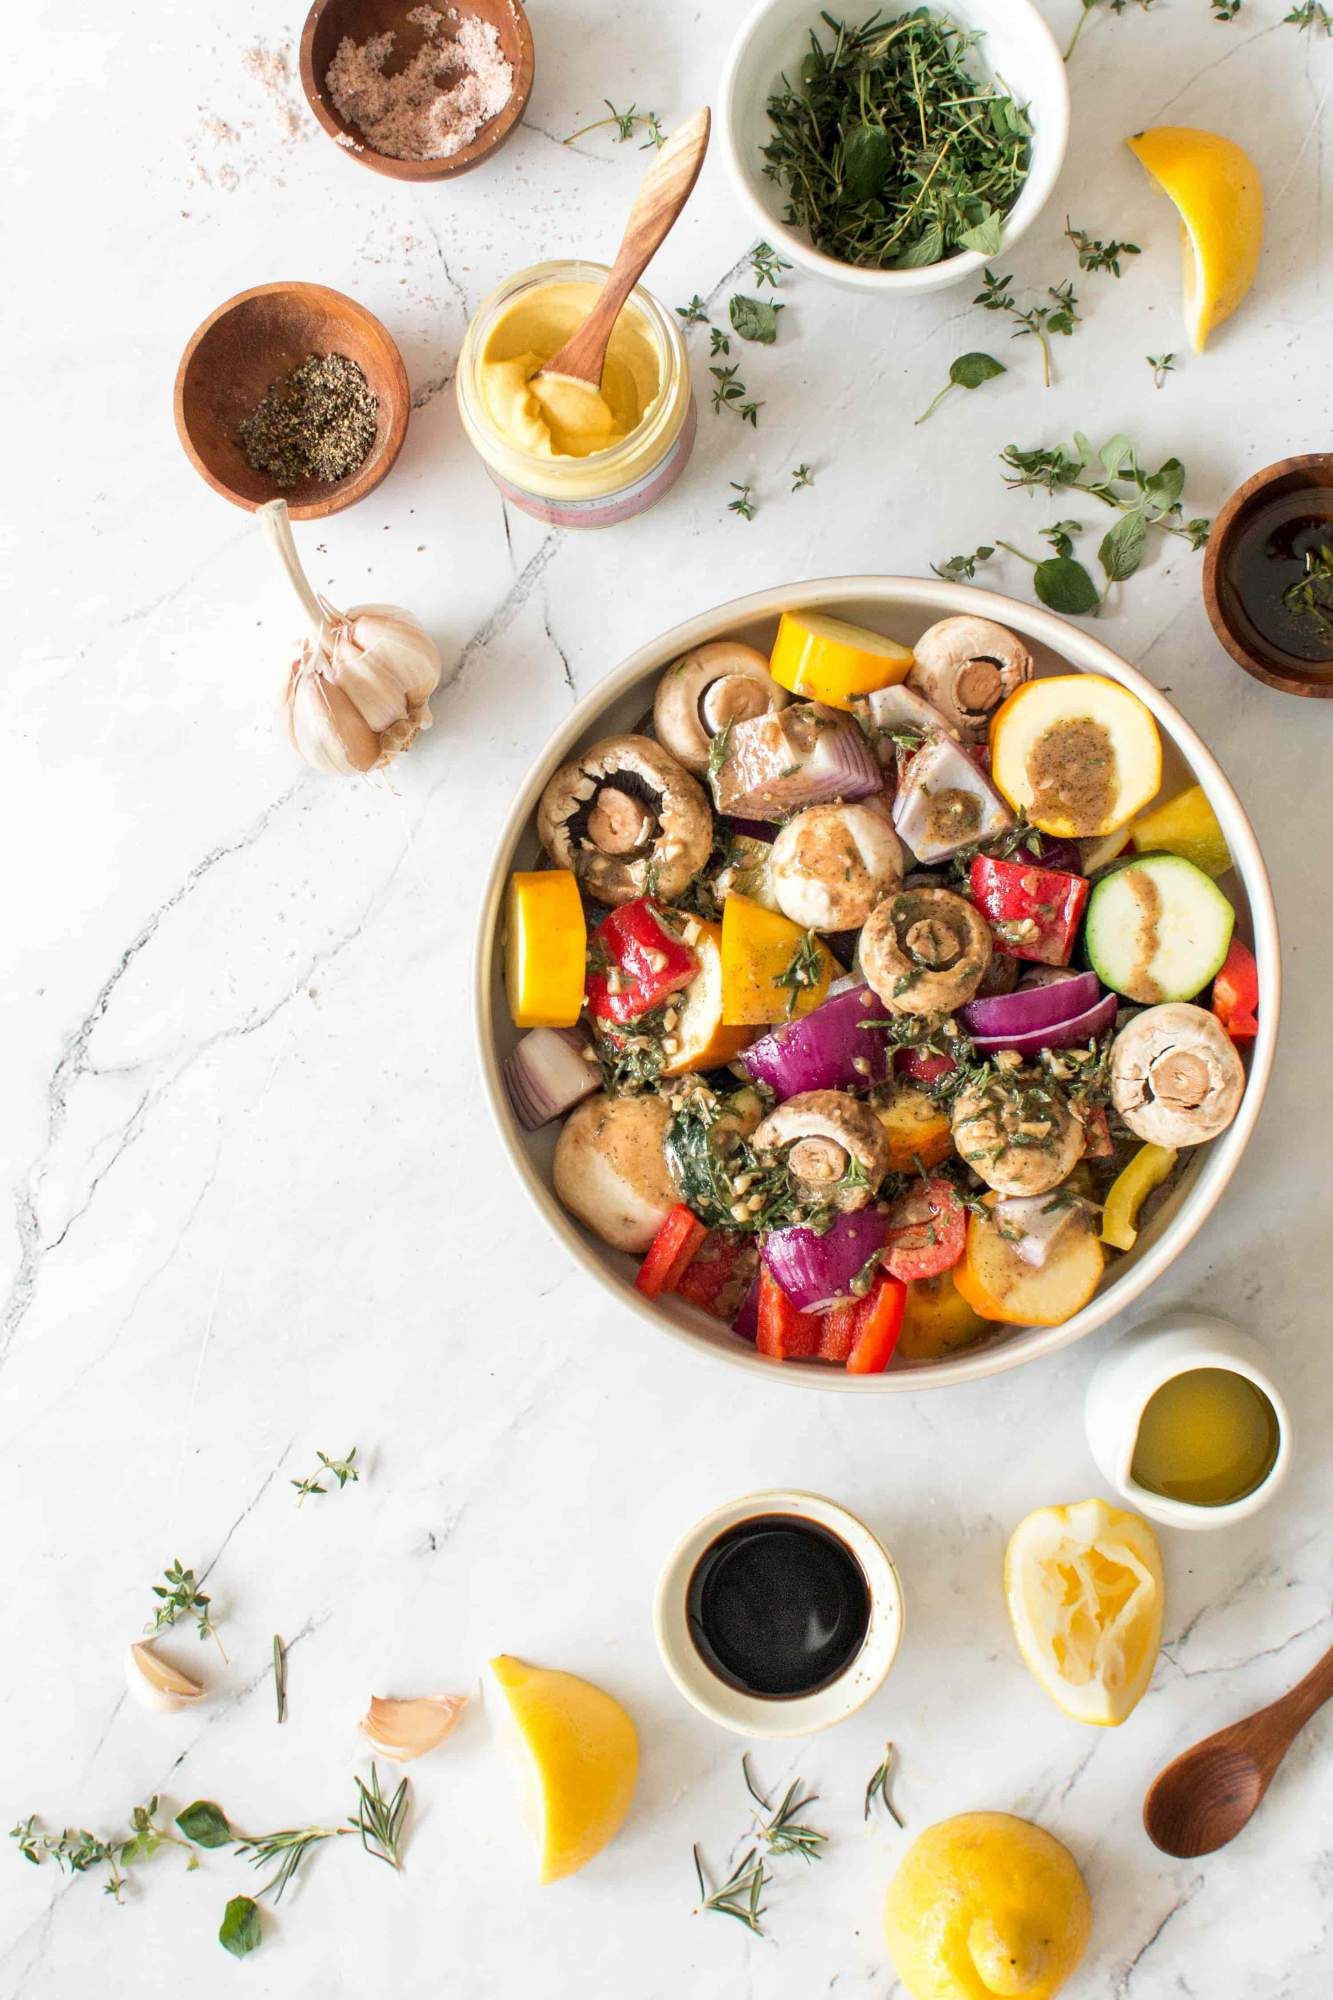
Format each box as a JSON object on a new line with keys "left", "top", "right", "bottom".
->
{"left": 476, "top": 284, "right": 660, "bottom": 458}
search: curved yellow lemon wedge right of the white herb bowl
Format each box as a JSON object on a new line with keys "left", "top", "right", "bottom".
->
{"left": 1125, "top": 126, "right": 1263, "bottom": 354}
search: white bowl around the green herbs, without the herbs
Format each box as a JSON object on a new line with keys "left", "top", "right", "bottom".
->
{"left": 719, "top": 0, "right": 1069, "bottom": 298}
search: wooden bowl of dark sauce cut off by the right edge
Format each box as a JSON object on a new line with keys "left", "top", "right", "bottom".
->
{"left": 1203, "top": 452, "right": 1333, "bottom": 700}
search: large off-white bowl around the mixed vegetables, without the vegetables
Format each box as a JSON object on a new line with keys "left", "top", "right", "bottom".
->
{"left": 476, "top": 576, "right": 1281, "bottom": 1396}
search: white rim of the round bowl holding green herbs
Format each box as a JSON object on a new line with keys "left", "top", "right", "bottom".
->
{"left": 717, "top": 0, "right": 1071, "bottom": 296}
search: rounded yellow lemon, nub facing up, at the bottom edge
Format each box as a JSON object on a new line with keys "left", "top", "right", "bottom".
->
{"left": 885, "top": 1812, "right": 1093, "bottom": 2000}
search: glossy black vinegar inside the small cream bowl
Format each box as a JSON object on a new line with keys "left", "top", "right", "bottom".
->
{"left": 685, "top": 1514, "right": 871, "bottom": 1700}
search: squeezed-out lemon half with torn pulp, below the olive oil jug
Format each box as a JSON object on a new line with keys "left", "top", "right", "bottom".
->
{"left": 1005, "top": 1500, "right": 1165, "bottom": 1728}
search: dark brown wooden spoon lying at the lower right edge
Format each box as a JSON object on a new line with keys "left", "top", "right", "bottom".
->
{"left": 1143, "top": 1646, "right": 1333, "bottom": 1860}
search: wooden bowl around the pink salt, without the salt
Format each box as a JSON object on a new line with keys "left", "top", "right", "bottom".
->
{"left": 300, "top": 0, "right": 534, "bottom": 182}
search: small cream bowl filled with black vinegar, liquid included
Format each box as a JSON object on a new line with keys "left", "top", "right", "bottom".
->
{"left": 654, "top": 1492, "right": 903, "bottom": 1736}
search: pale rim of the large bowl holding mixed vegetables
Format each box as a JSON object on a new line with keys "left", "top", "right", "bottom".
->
{"left": 472, "top": 576, "right": 1281, "bottom": 1396}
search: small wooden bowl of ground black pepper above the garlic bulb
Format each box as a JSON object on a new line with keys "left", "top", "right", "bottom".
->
{"left": 174, "top": 284, "right": 412, "bottom": 520}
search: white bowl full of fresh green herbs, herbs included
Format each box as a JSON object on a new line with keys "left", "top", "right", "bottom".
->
{"left": 719, "top": 0, "right": 1069, "bottom": 296}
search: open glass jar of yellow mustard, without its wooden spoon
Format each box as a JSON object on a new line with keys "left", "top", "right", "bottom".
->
{"left": 454, "top": 260, "right": 695, "bottom": 528}
